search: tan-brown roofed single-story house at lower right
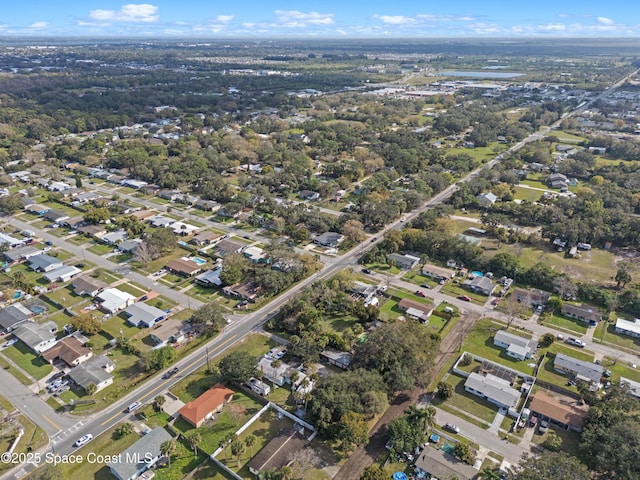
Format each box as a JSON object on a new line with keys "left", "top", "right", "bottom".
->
{"left": 529, "top": 390, "right": 588, "bottom": 432}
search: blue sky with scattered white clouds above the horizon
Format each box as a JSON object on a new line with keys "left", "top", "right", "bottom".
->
{"left": 0, "top": 0, "right": 640, "bottom": 38}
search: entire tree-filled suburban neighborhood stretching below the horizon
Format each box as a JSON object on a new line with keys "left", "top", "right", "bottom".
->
{"left": 0, "top": 35, "right": 640, "bottom": 480}
